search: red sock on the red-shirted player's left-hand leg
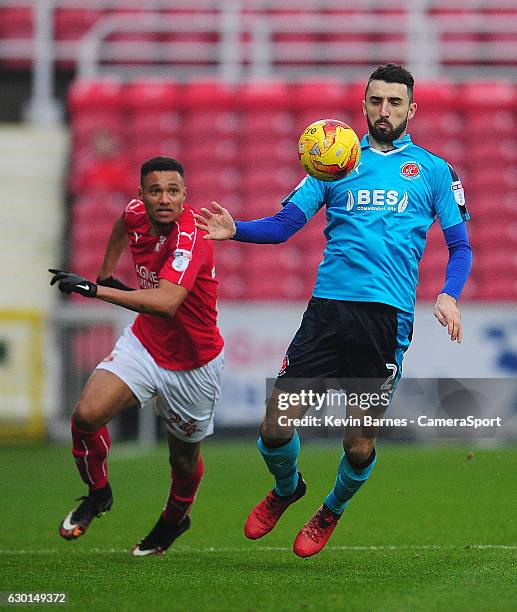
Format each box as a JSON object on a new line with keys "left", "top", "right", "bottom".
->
{"left": 72, "top": 418, "right": 111, "bottom": 490}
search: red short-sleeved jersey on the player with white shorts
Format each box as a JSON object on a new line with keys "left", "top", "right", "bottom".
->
{"left": 122, "top": 200, "right": 223, "bottom": 370}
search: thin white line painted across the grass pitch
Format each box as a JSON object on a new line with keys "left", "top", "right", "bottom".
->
{"left": 0, "top": 544, "right": 517, "bottom": 555}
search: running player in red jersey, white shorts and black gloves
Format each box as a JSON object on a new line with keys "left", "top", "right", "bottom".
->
{"left": 50, "top": 157, "right": 224, "bottom": 556}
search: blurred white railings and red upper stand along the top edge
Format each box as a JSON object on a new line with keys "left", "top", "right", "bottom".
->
{"left": 0, "top": 0, "right": 517, "bottom": 121}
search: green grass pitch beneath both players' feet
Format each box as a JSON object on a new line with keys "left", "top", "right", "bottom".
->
{"left": 0, "top": 440, "right": 517, "bottom": 612}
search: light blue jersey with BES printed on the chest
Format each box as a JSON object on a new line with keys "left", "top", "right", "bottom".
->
{"left": 283, "top": 134, "right": 470, "bottom": 313}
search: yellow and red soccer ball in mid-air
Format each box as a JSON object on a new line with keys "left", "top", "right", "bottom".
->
{"left": 298, "top": 119, "right": 361, "bottom": 181}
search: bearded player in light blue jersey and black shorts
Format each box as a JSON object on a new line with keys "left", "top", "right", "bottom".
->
{"left": 197, "top": 64, "right": 472, "bottom": 557}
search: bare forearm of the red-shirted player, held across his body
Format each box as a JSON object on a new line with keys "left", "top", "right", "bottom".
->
{"left": 96, "top": 283, "right": 187, "bottom": 317}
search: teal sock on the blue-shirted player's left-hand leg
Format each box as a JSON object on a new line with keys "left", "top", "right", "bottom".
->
{"left": 257, "top": 432, "right": 300, "bottom": 497}
